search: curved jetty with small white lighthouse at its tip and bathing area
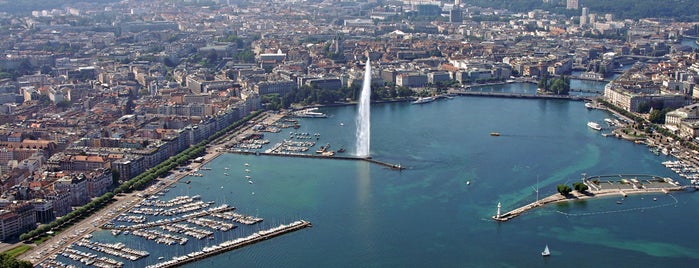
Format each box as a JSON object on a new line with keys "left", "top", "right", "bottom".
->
{"left": 492, "top": 174, "right": 695, "bottom": 222}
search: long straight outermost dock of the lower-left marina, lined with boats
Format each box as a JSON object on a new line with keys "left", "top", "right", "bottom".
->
{"left": 146, "top": 220, "right": 312, "bottom": 268}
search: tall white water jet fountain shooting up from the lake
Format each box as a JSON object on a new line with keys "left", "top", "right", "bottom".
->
{"left": 356, "top": 58, "right": 371, "bottom": 157}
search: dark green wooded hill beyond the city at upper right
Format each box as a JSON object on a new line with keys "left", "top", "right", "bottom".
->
{"left": 463, "top": 0, "right": 699, "bottom": 21}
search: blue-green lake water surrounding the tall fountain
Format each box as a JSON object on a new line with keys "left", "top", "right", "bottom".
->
{"left": 59, "top": 85, "right": 699, "bottom": 267}
